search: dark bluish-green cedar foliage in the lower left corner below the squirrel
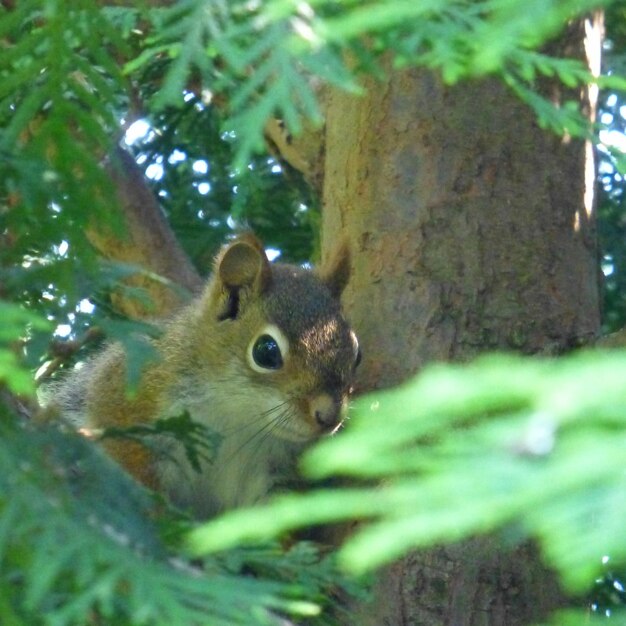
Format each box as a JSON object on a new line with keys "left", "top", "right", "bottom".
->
{"left": 0, "top": 409, "right": 360, "bottom": 626}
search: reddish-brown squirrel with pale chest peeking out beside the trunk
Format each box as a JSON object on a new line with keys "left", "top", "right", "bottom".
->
{"left": 50, "top": 235, "right": 360, "bottom": 518}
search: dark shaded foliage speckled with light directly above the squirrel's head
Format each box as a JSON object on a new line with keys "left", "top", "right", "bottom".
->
{"left": 129, "top": 92, "right": 318, "bottom": 275}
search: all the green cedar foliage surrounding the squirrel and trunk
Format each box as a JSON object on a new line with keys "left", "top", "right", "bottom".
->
{"left": 0, "top": 0, "right": 626, "bottom": 626}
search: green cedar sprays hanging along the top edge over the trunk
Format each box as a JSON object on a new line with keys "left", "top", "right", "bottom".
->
{"left": 126, "top": 0, "right": 624, "bottom": 166}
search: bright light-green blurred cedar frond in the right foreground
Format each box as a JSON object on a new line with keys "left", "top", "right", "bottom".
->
{"left": 188, "top": 351, "right": 626, "bottom": 624}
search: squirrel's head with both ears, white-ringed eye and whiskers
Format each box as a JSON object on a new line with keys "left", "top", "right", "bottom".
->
{"left": 199, "top": 235, "right": 360, "bottom": 441}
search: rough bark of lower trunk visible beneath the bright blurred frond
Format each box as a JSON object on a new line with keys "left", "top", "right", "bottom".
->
{"left": 358, "top": 538, "right": 564, "bottom": 626}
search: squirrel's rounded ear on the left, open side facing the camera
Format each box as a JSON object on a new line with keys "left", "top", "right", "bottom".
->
{"left": 216, "top": 235, "right": 271, "bottom": 292}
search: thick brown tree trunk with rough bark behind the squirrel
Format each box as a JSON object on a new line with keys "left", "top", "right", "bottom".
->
{"left": 322, "top": 15, "right": 600, "bottom": 626}
